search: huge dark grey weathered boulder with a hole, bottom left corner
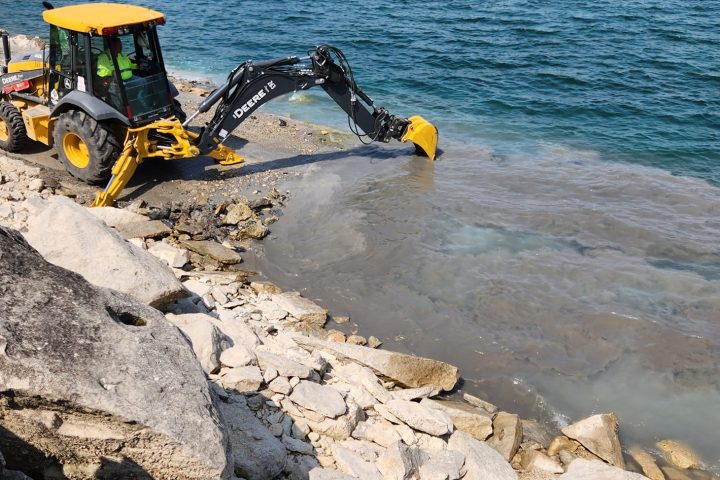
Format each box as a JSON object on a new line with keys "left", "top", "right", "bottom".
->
{"left": 0, "top": 227, "right": 232, "bottom": 479}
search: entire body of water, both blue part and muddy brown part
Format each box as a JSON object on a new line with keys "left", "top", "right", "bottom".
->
{"left": 0, "top": 0, "right": 720, "bottom": 471}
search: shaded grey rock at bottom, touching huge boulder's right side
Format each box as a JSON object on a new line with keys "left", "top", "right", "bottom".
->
{"left": 220, "top": 400, "right": 287, "bottom": 480}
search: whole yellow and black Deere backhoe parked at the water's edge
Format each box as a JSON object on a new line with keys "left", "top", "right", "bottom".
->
{"left": 0, "top": 2, "right": 438, "bottom": 206}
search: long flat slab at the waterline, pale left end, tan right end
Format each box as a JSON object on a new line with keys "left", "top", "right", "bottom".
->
{"left": 295, "top": 336, "right": 458, "bottom": 393}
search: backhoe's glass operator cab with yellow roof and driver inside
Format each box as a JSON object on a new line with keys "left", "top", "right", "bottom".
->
{"left": 43, "top": 3, "right": 174, "bottom": 126}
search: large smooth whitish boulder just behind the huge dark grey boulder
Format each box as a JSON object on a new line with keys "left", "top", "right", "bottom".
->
{"left": 25, "top": 197, "right": 186, "bottom": 306}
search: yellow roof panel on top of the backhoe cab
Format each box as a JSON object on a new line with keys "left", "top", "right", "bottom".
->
{"left": 43, "top": 3, "right": 165, "bottom": 35}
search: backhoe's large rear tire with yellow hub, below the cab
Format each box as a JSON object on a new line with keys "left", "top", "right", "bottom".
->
{"left": 53, "top": 110, "right": 122, "bottom": 185}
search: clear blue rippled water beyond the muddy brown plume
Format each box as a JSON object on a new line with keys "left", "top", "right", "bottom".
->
{"left": 0, "top": 0, "right": 720, "bottom": 184}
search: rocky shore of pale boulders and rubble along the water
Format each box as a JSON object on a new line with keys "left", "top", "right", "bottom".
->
{"left": 0, "top": 33, "right": 717, "bottom": 480}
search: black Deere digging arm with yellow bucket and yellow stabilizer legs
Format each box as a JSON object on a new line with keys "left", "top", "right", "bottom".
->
{"left": 92, "top": 45, "right": 438, "bottom": 206}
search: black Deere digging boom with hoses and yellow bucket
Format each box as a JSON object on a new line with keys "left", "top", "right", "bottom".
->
{"left": 188, "top": 45, "right": 438, "bottom": 159}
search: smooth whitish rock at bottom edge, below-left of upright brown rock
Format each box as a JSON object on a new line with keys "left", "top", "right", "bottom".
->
{"left": 448, "top": 431, "right": 517, "bottom": 480}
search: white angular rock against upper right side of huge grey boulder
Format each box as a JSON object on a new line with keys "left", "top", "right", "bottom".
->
{"left": 165, "top": 313, "right": 229, "bottom": 373}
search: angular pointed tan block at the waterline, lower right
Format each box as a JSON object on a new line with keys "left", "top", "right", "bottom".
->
{"left": 562, "top": 413, "right": 625, "bottom": 468}
